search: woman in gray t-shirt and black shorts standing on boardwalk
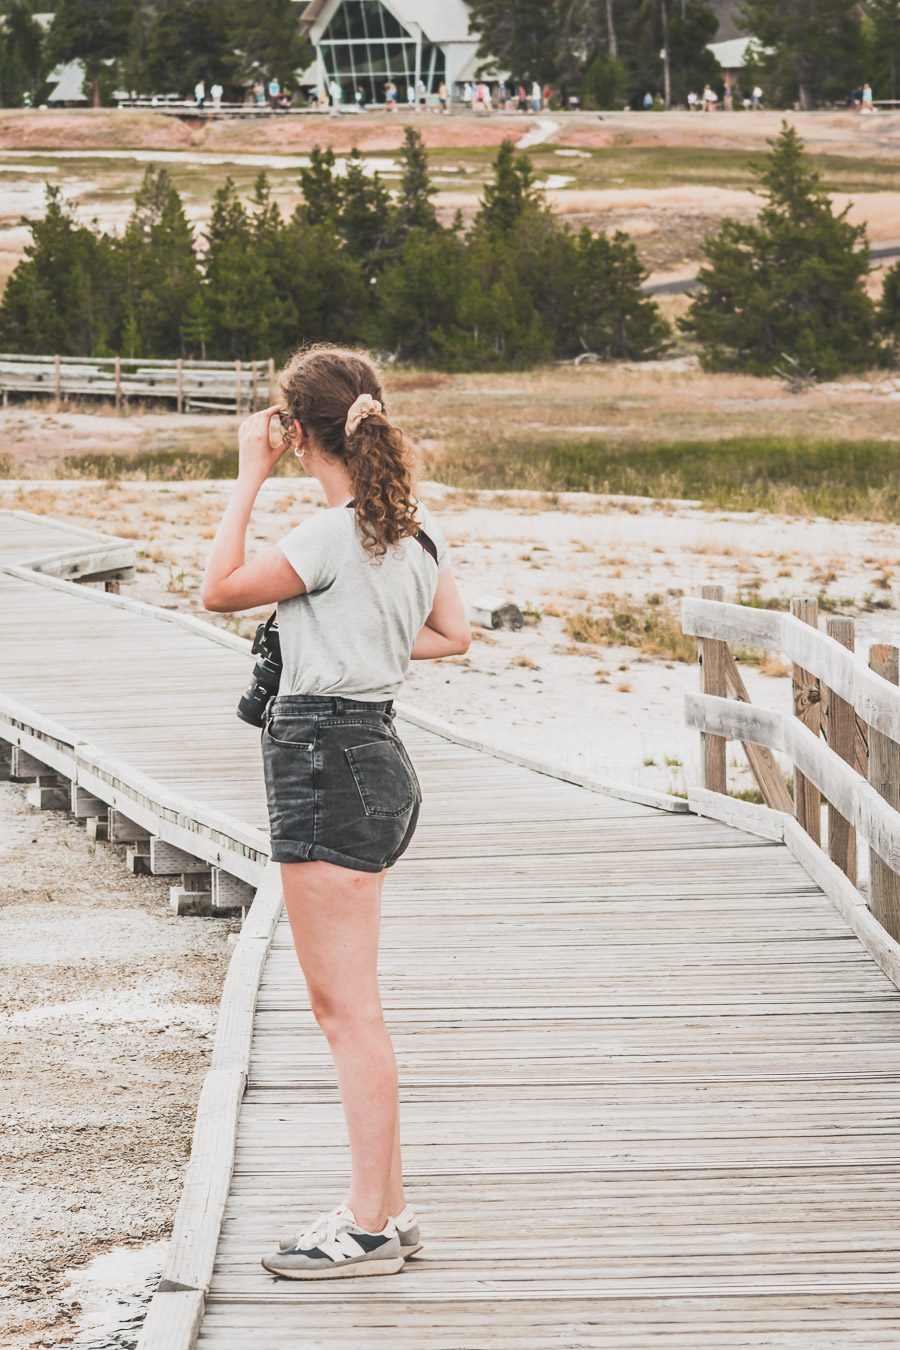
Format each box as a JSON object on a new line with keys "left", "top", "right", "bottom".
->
{"left": 202, "top": 347, "right": 471, "bottom": 1278}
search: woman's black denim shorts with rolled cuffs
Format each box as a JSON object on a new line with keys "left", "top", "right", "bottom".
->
{"left": 262, "top": 694, "right": 422, "bottom": 872}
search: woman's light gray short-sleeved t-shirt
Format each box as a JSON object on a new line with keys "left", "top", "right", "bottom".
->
{"left": 278, "top": 502, "right": 451, "bottom": 703}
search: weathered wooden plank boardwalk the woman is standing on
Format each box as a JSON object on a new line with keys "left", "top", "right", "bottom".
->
{"left": 0, "top": 514, "right": 900, "bottom": 1350}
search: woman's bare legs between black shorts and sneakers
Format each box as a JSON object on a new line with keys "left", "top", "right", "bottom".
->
{"left": 281, "top": 861, "right": 405, "bottom": 1233}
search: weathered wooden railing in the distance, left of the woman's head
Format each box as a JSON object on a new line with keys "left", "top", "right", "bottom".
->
{"left": 0, "top": 354, "right": 275, "bottom": 414}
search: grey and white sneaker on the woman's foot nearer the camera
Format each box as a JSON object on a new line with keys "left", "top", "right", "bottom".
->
{"left": 262, "top": 1207, "right": 403, "bottom": 1280}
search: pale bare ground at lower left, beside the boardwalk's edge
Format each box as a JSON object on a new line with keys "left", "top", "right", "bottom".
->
{"left": 0, "top": 783, "right": 236, "bottom": 1350}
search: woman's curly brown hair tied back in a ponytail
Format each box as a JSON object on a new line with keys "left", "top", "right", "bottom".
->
{"left": 281, "top": 343, "right": 420, "bottom": 558}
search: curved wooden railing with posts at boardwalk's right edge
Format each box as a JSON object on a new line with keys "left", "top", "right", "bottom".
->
{"left": 681, "top": 586, "right": 900, "bottom": 977}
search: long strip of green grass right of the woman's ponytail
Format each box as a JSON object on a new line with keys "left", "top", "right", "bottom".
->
{"left": 425, "top": 436, "right": 900, "bottom": 521}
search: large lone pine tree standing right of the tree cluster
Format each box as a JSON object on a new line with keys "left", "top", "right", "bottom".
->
{"left": 681, "top": 123, "right": 877, "bottom": 378}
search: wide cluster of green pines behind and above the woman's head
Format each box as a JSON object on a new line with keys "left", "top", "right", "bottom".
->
{"left": 0, "top": 128, "right": 668, "bottom": 370}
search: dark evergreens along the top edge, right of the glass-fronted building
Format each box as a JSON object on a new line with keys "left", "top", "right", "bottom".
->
{"left": 471, "top": 0, "right": 900, "bottom": 108}
